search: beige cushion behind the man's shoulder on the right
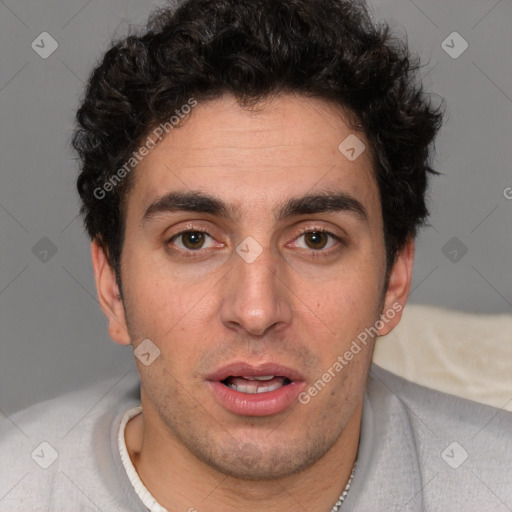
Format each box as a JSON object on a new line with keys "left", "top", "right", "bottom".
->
{"left": 373, "top": 305, "right": 512, "bottom": 411}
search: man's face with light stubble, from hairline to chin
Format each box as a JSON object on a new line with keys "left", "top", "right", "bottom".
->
{"left": 109, "top": 95, "right": 404, "bottom": 479}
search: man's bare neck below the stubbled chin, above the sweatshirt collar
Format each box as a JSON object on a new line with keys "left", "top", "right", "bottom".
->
{"left": 125, "top": 404, "right": 362, "bottom": 512}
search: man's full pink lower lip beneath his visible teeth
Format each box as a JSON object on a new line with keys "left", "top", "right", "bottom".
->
{"left": 209, "top": 381, "right": 305, "bottom": 416}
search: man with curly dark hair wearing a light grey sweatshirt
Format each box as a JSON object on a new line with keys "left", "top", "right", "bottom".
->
{"left": 0, "top": 0, "right": 512, "bottom": 512}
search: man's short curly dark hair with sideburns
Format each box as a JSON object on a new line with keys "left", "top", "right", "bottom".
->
{"left": 73, "top": 0, "right": 442, "bottom": 282}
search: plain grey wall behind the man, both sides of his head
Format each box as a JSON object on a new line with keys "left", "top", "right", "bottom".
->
{"left": 0, "top": 0, "right": 512, "bottom": 416}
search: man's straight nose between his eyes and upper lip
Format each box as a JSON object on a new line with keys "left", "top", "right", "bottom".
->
{"left": 220, "top": 244, "right": 292, "bottom": 336}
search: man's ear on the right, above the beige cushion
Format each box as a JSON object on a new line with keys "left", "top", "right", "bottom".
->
{"left": 379, "top": 239, "right": 414, "bottom": 336}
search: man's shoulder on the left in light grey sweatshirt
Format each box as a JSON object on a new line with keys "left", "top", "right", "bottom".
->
{"left": 0, "top": 370, "right": 139, "bottom": 511}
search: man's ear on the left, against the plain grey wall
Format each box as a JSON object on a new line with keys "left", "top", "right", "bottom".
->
{"left": 91, "top": 240, "right": 131, "bottom": 345}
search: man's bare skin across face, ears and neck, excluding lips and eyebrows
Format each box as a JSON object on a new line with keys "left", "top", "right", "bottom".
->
{"left": 92, "top": 95, "right": 414, "bottom": 512}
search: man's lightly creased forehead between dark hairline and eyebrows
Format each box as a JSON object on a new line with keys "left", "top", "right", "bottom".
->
{"left": 128, "top": 95, "right": 380, "bottom": 220}
